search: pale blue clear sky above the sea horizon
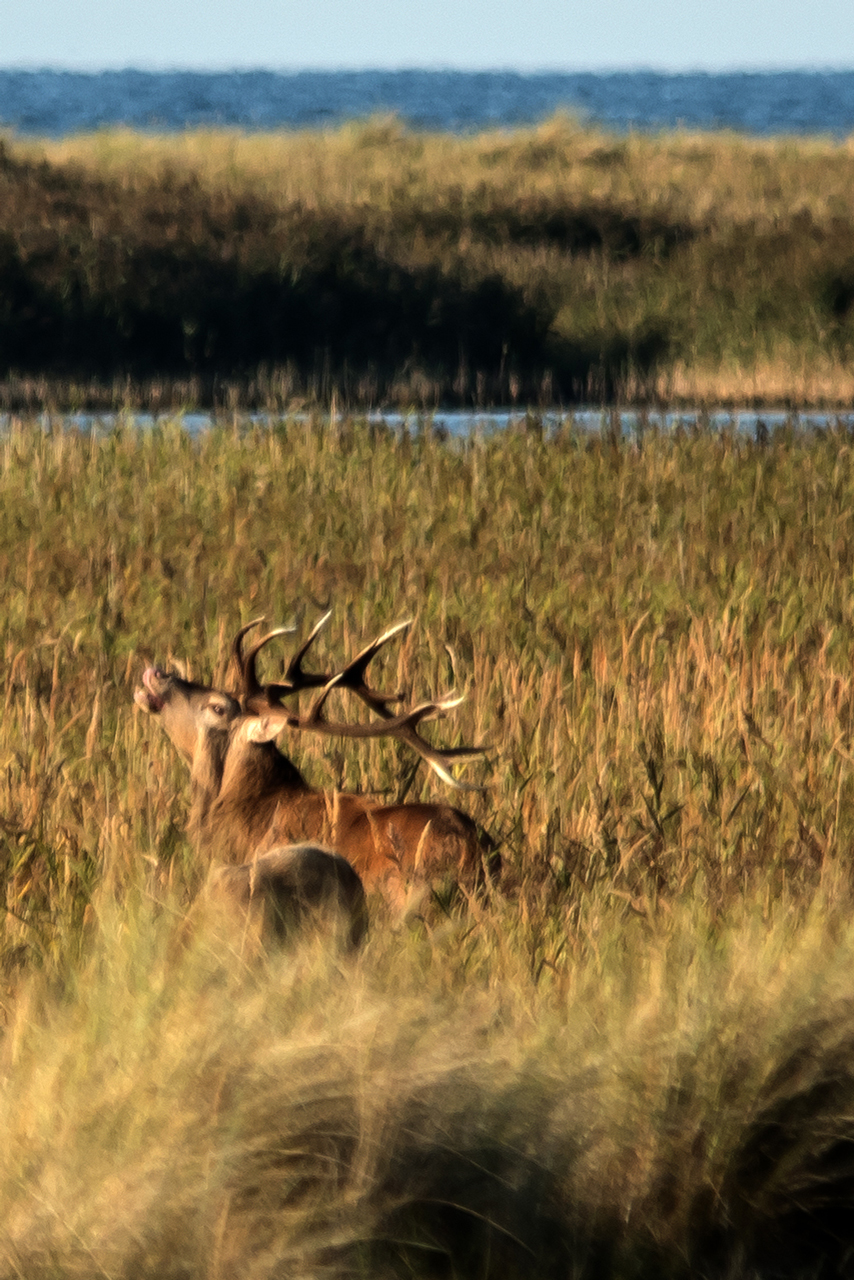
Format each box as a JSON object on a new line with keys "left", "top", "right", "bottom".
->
{"left": 0, "top": 0, "right": 854, "bottom": 70}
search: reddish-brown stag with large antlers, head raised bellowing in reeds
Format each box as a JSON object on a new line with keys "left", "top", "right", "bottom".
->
{"left": 134, "top": 614, "right": 498, "bottom": 905}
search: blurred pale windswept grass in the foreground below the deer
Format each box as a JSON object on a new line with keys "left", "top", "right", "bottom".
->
{"left": 8, "top": 885, "right": 854, "bottom": 1280}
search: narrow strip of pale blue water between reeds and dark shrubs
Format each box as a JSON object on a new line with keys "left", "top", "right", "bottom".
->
{"left": 10, "top": 408, "right": 854, "bottom": 442}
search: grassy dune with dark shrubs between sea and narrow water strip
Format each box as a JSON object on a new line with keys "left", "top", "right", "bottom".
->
{"left": 0, "top": 116, "right": 854, "bottom": 410}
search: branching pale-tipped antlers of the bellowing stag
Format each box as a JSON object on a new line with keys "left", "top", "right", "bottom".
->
{"left": 234, "top": 613, "right": 485, "bottom": 791}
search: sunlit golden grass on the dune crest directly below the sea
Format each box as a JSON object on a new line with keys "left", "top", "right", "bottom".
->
{"left": 23, "top": 114, "right": 854, "bottom": 225}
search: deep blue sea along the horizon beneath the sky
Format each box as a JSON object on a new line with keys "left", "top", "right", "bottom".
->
{"left": 0, "top": 70, "right": 854, "bottom": 137}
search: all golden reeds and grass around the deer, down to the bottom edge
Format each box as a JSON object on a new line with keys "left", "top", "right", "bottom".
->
{"left": 0, "top": 417, "right": 854, "bottom": 1277}
